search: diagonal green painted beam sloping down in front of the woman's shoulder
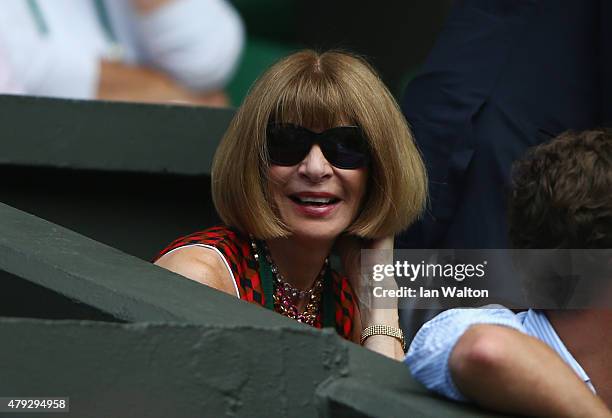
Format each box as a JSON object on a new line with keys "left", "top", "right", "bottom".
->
{"left": 0, "top": 204, "right": 296, "bottom": 327}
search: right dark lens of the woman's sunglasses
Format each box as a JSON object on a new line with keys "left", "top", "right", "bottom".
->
{"left": 321, "top": 127, "right": 369, "bottom": 169}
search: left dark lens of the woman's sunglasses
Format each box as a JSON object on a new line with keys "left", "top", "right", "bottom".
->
{"left": 268, "top": 125, "right": 311, "bottom": 166}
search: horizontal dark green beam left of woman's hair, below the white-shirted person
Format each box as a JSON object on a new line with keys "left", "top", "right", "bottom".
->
{"left": 0, "top": 95, "right": 234, "bottom": 175}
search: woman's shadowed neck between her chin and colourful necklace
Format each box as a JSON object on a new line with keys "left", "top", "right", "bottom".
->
{"left": 266, "top": 237, "right": 334, "bottom": 290}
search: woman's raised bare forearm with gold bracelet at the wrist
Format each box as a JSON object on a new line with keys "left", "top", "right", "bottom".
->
{"left": 336, "top": 235, "right": 404, "bottom": 360}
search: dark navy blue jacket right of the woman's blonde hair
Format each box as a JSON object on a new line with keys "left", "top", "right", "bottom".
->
{"left": 396, "top": 0, "right": 612, "bottom": 248}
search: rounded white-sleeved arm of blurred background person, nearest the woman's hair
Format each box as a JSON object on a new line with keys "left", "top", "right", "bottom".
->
{"left": 131, "top": 0, "right": 245, "bottom": 92}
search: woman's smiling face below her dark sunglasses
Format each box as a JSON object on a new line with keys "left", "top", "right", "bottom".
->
{"left": 268, "top": 122, "right": 368, "bottom": 240}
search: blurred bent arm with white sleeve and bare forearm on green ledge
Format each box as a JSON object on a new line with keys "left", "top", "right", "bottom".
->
{"left": 0, "top": 2, "right": 227, "bottom": 106}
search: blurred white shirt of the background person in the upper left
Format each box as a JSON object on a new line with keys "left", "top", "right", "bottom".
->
{"left": 0, "top": 0, "right": 244, "bottom": 98}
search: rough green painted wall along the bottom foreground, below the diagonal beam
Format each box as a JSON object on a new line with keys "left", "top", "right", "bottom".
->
{"left": 0, "top": 318, "right": 506, "bottom": 418}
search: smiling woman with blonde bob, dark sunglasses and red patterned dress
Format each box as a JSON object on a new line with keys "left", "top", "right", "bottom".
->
{"left": 157, "top": 50, "right": 427, "bottom": 358}
